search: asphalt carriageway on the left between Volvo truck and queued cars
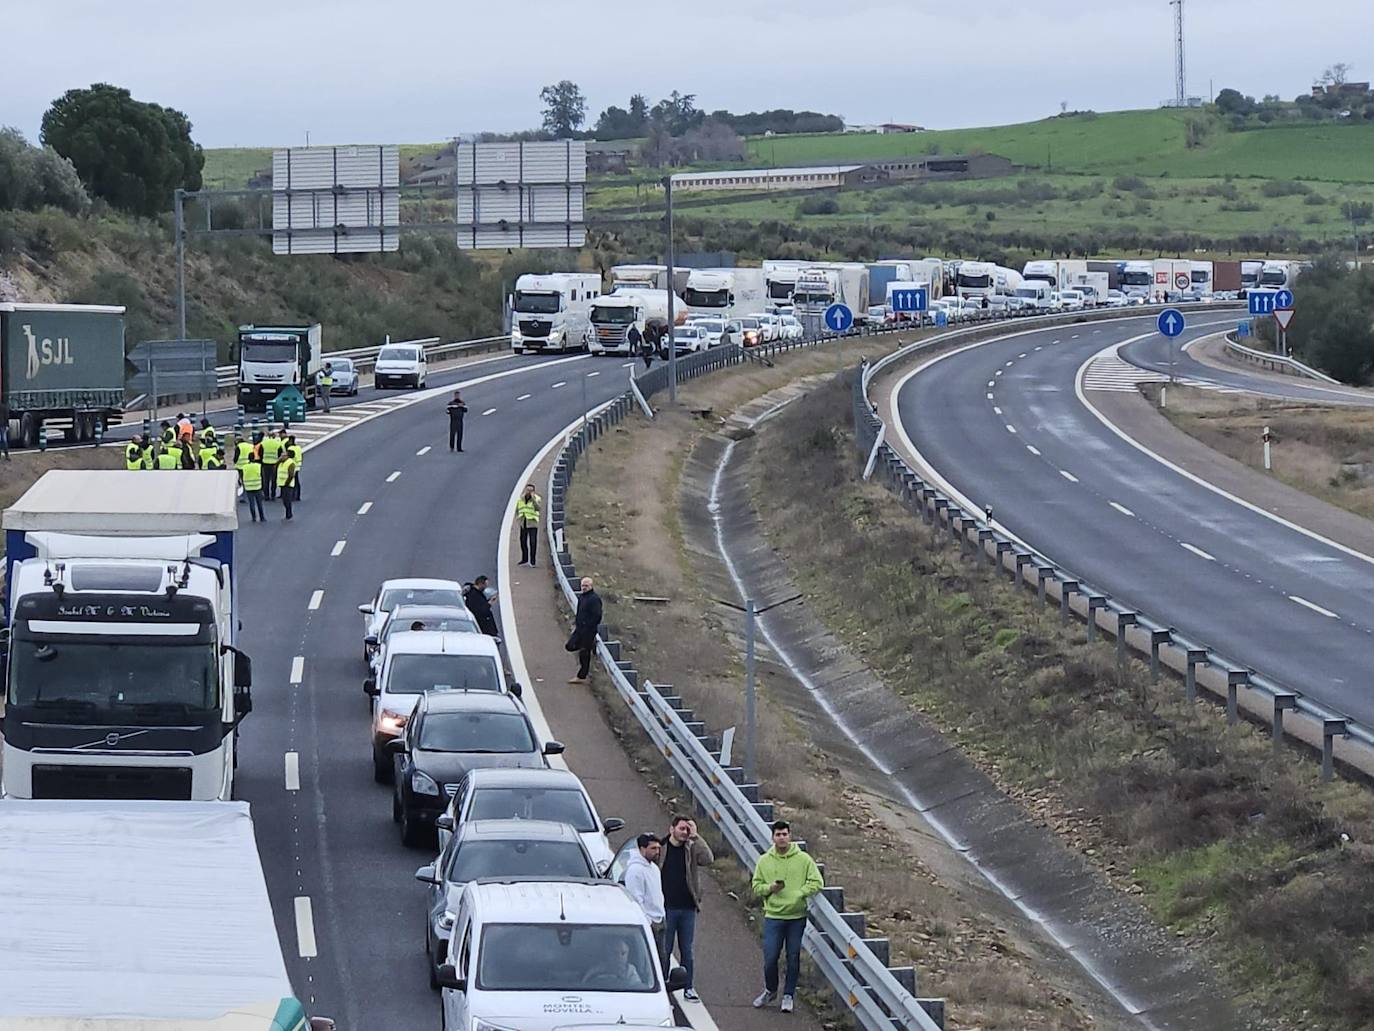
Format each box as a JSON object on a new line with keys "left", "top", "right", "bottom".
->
{"left": 238, "top": 357, "right": 640, "bottom": 1030}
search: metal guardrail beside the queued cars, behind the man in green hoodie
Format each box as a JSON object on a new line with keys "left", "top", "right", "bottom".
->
{"left": 548, "top": 351, "right": 944, "bottom": 1031}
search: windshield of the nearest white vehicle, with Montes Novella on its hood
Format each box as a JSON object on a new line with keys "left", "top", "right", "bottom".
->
{"left": 477, "top": 922, "right": 658, "bottom": 993}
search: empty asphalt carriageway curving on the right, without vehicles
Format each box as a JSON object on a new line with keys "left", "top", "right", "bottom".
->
{"left": 896, "top": 313, "right": 1374, "bottom": 722}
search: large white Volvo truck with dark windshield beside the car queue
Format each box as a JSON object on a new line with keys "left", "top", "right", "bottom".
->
{"left": 0, "top": 469, "right": 250, "bottom": 808}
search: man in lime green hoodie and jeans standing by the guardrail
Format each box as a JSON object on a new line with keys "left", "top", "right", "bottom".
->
{"left": 753, "top": 819, "right": 826, "bottom": 1013}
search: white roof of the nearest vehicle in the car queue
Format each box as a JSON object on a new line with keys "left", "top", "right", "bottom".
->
{"left": 463, "top": 878, "right": 644, "bottom": 927}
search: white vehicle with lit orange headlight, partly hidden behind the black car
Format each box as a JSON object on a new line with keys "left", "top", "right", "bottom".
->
{"left": 363, "top": 631, "right": 522, "bottom": 784}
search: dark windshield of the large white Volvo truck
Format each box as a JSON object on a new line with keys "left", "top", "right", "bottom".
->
{"left": 10, "top": 635, "right": 220, "bottom": 724}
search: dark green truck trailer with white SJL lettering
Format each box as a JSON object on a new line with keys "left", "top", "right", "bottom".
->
{"left": 0, "top": 302, "right": 125, "bottom": 447}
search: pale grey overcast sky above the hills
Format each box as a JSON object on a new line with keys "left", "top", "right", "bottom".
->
{"left": 0, "top": 0, "right": 1374, "bottom": 147}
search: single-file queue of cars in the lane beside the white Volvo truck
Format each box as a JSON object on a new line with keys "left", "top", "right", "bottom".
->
{"left": 359, "top": 574, "right": 695, "bottom": 1031}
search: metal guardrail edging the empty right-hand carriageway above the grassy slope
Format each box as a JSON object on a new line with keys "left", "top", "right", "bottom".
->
{"left": 853, "top": 302, "right": 1374, "bottom": 779}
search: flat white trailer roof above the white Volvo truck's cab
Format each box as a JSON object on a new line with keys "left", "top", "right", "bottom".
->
{"left": 0, "top": 469, "right": 239, "bottom": 536}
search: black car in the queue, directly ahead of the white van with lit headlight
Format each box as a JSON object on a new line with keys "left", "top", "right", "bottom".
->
{"left": 387, "top": 690, "right": 563, "bottom": 845}
